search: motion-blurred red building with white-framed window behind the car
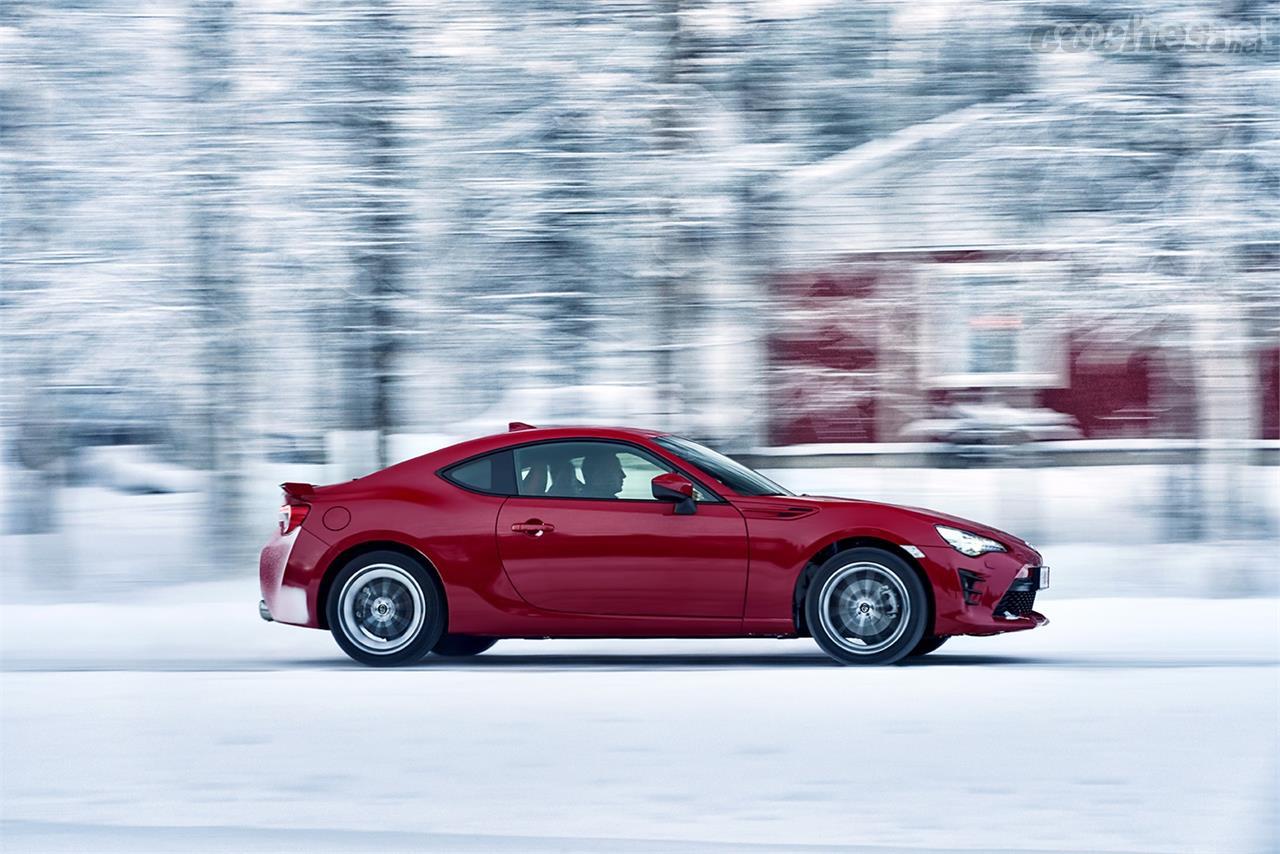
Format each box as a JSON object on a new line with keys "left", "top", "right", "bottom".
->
{"left": 768, "top": 250, "right": 1233, "bottom": 444}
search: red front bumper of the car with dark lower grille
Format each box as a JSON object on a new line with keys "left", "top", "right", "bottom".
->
{"left": 920, "top": 547, "right": 1048, "bottom": 635}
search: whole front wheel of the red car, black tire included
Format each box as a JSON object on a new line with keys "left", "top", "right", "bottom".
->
{"left": 805, "top": 548, "right": 929, "bottom": 665}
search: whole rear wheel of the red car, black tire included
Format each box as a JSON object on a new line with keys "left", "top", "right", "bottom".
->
{"left": 325, "top": 552, "right": 447, "bottom": 667}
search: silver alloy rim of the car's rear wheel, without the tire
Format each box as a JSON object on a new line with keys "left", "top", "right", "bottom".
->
{"left": 338, "top": 563, "right": 426, "bottom": 656}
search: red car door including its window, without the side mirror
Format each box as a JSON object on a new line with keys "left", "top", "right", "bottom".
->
{"left": 497, "top": 440, "right": 748, "bottom": 617}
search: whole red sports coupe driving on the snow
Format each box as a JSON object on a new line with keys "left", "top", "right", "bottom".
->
{"left": 259, "top": 424, "right": 1048, "bottom": 666}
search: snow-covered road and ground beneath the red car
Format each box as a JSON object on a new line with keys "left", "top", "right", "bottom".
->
{"left": 0, "top": 594, "right": 1280, "bottom": 854}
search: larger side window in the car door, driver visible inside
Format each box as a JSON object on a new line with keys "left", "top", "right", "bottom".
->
{"left": 516, "top": 442, "right": 671, "bottom": 501}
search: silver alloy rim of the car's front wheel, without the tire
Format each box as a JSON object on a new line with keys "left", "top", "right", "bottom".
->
{"left": 818, "top": 561, "right": 911, "bottom": 656}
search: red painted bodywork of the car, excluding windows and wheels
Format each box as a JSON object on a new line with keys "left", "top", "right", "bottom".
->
{"left": 260, "top": 428, "right": 1043, "bottom": 638}
